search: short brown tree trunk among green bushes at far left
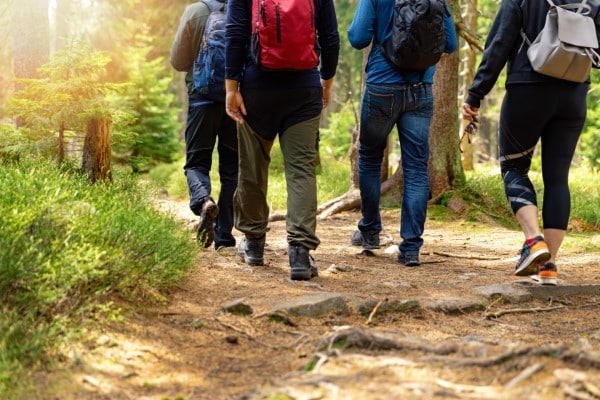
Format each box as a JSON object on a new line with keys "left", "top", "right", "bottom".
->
{"left": 82, "top": 117, "right": 112, "bottom": 183}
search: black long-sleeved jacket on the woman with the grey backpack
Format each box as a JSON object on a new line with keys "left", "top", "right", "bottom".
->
{"left": 466, "top": 0, "right": 600, "bottom": 107}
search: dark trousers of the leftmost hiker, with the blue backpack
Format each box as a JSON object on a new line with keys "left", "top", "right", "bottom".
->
{"left": 183, "top": 98, "right": 238, "bottom": 247}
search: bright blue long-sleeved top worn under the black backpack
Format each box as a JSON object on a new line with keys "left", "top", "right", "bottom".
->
{"left": 348, "top": 0, "right": 457, "bottom": 84}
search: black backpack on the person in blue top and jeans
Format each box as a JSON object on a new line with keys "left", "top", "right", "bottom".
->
{"left": 381, "top": 0, "right": 446, "bottom": 71}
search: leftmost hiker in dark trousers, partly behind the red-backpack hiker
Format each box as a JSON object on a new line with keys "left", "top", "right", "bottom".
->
{"left": 171, "top": 0, "right": 238, "bottom": 249}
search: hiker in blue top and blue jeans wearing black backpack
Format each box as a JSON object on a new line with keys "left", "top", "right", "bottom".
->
{"left": 348, "top": 0, "right": 457, "bottom": 267}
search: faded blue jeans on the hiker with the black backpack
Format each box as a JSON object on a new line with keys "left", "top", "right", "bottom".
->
{"left": 358, "top": 83, "right": 433, "bottom": 253}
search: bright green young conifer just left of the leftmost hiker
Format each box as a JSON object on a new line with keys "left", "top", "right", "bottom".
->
{"left": 112, "top": 34, "right": 182, "bottom": 172}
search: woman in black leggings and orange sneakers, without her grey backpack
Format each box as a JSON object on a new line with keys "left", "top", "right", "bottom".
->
{"left": 462, "top": 0, "right": 600, "bottom": 285}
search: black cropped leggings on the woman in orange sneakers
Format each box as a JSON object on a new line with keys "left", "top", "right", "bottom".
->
{"left": 498, "top": 80, "right": 588, "bottom": 230}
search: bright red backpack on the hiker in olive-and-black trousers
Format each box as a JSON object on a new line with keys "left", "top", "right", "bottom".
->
{"left": 251, "top": 0, "right": 319, "bottom": 70}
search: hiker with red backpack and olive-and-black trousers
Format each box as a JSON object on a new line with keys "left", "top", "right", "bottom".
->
{"left": 225, "top": 0, "right": 340, "bottom": 280}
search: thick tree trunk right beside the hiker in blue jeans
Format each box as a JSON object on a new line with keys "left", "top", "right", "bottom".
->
{"left": 429, "top": 31, "right": 464, "bottom": 197}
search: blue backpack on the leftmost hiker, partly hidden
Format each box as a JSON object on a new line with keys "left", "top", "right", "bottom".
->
{"left": 193, "top": 0, "right": 227, "bottom": 102}
